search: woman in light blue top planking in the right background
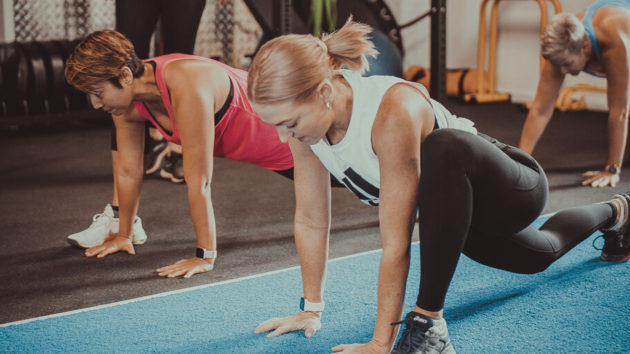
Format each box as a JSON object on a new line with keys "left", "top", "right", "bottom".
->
{"left": 519, "top": 0, "right": 630, "bottom": 187}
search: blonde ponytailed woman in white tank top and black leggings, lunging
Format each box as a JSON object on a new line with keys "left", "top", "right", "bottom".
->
{"left": 248, "top": 21, "right": 630, "bottom": 353}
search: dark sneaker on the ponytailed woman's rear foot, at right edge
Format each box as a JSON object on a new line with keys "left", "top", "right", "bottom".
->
{"left": 593, "top": 192, "right": 630, "bottom": 262}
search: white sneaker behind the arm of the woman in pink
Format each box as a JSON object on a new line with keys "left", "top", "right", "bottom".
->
{"left": 67, "top": 204, "right": 147, "bottom": 248}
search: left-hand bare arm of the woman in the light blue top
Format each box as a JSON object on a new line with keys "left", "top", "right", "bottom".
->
{"left": 519, "top": 60, "right": 564, "bottom": 154}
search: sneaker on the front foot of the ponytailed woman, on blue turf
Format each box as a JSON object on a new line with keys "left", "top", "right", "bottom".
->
{"left": 392, "top": 311, "right": 455, "bottom": 354}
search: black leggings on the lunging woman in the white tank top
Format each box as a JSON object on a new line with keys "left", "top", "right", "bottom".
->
{"left": 416, "top": 129, "right": 616, "bottom": 311}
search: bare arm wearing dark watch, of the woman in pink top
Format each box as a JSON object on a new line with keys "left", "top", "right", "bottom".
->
{"left": 158, "top": 61, "right": 229, "bottom": 278}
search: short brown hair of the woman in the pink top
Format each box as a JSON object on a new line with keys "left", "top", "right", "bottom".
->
{"left": 65, "top": 30, "right": 144, "bottom": 92}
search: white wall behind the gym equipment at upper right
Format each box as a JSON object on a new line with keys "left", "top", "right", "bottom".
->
{"left": 386, "top": 0, "right": 607, "bottom": 110}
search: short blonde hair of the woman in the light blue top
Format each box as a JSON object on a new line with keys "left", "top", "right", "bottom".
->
{"left": 541, "top": 12, "right": 586, "bottom": 62}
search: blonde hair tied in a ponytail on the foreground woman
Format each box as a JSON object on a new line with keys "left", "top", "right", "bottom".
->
{"left": 247, "top": 17, "right": 378, "bottom": 104}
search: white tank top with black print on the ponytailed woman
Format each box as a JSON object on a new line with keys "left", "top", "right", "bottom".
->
{"left": 311, "top": 70, "right": 477, "bottom": 206}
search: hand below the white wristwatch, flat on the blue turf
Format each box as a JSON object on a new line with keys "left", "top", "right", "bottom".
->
{"left": 254, "top": 311, "right": 322, "bottom": 338}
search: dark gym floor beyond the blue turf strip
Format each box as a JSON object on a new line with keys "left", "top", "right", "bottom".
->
{"left": 0, "top": 100, "right": 630, "bottom": 323}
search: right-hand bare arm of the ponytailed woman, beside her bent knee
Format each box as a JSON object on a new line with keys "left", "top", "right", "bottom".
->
{"left": 372, "top": 85, "right": 433, "bottom": 348}
